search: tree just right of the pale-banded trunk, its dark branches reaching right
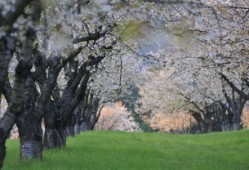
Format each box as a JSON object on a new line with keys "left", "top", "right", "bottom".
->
{"left": 22, "top": 0, "right": 118, "bottom": 151}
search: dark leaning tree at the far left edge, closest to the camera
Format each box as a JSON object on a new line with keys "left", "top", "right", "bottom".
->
{"left": 0, "top": 0, "right": 40, "bottom": 167}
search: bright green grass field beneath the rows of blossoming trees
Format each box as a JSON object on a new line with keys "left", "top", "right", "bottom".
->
{"left": 3, "top": 130, "right": 249, "bottom": 170}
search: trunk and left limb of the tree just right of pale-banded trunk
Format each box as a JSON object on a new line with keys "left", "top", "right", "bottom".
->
{"left": 37, "top": 48, "right": 82, "bottom": 148}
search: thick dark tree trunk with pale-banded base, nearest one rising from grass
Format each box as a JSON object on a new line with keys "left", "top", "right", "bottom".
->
{"left": 17, "top": 54, "right": 43, "bottom": 159}
